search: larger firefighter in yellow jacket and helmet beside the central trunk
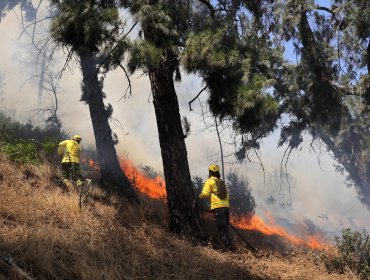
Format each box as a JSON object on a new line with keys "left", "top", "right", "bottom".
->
{"left": 199, "top": 164, "right": 234, "bottom": 250}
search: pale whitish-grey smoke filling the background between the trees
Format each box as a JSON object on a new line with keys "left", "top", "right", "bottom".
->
{"left": 0, "top": 2, "right": 370, "bottom": 237}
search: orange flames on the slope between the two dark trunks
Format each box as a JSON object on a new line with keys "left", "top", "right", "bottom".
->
{"left": 120, "top": 159, "right": 167, "bottom": 199}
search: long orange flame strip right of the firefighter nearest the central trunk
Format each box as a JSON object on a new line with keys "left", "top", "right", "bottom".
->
{"left": 232, "top": 213, "right": 328, "bottom": 250}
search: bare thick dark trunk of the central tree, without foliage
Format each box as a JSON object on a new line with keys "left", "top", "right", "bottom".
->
{"left": 149, "top": 59, "right": 200, "bottom": 235}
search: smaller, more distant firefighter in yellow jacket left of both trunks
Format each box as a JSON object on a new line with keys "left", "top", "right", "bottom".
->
{"left": 58, "top": 135, "right": 83, "bottom": 187}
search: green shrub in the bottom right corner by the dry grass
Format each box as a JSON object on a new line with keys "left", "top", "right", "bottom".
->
{"left": 322, "top": 228, "right": 370, "bottom": 279}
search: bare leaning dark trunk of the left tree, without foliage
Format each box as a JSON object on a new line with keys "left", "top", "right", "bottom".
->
{"left": 80, "top": 53, "right": 138, "bottom": 201}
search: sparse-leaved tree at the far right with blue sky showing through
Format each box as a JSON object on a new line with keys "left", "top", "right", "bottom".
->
{"left": 276, "top": 0, "right": 370, "bottom": 207}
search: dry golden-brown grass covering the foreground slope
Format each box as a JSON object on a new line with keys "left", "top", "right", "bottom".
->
{"left": 0, "top": 159, "right": 356, "bottom": 280}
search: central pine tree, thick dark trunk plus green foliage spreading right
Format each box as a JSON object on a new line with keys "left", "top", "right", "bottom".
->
{"left": 115, "top": 0, "right": 278, "bottom": 233}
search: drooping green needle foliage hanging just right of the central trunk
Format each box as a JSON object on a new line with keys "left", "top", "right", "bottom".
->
{"left": 182, "top": 1, "right": 282, "bottom": 151}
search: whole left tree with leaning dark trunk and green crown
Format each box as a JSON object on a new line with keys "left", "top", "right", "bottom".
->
{"left": 50, "top": 0, "right": 137, "bottom": 200}
